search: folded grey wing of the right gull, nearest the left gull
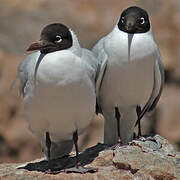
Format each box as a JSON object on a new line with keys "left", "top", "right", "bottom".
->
{"left": 92, "top": 39, "right": 108, "bottom": 114}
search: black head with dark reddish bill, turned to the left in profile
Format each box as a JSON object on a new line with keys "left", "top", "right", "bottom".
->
{"left": 27, "top": 23, "right": 72, "bottom": 54}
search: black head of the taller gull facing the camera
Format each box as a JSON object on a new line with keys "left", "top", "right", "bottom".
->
{"left": 118, "top": 6, "right": 150, "bottom": 34}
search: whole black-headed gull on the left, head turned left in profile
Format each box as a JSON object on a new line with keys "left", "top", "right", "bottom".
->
{"left": 16, "top": 23, "right": 100, "bottom": 172}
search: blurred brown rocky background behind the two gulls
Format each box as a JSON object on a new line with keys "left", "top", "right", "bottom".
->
{"left": 0, "top": 0, "right": 180, "bottom": 163}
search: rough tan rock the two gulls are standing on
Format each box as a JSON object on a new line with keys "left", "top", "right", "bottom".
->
{"left": 0, "top": 135, "right": 180, "bottom": 180}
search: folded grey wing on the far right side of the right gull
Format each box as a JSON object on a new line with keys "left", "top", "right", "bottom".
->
{"left": 136, "top": 50, "right": 164, "bottom": 125}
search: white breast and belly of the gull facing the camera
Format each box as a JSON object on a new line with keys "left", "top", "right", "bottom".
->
{"left": 100, "top": 28, "right": 155, "bottom": 107}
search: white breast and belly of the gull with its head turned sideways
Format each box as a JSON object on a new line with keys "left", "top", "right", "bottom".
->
{"left": 25, "top": 51, "right": 95, "bottom": 141}
